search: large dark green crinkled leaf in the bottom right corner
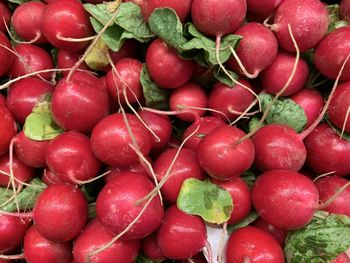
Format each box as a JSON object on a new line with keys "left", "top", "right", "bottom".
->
{"left": 284, "top": 214, "right": 350, "bottom": 263}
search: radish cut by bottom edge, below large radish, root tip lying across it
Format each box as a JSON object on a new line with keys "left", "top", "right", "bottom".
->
{"left": 73, "top": 219, "right": 140, "bottom": 263}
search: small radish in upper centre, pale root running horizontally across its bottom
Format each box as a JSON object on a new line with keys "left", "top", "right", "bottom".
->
{"left": 169, "top": 82, "right": 207, "bottom": 122}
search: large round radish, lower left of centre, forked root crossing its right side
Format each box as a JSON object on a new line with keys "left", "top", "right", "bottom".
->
{"left": 96, "top": 173, "right": 164, "bottom": 240}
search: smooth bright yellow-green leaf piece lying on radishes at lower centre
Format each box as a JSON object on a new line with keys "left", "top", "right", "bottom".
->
{"left": 177, "top": 178, "right": 233, "bottom": 224}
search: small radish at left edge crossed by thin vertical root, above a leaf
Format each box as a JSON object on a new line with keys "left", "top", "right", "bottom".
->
{"left": 0, "top": 155, "right": 35, "bottom": 187}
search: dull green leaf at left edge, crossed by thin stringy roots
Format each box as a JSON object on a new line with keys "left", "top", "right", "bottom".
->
{"left": 0, "top": 178, "right": 47, "bottom": 212}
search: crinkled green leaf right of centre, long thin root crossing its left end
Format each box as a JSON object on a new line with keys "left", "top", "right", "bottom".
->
{"left": 259, "top": 94, "right": 307, "bottom": 132}
